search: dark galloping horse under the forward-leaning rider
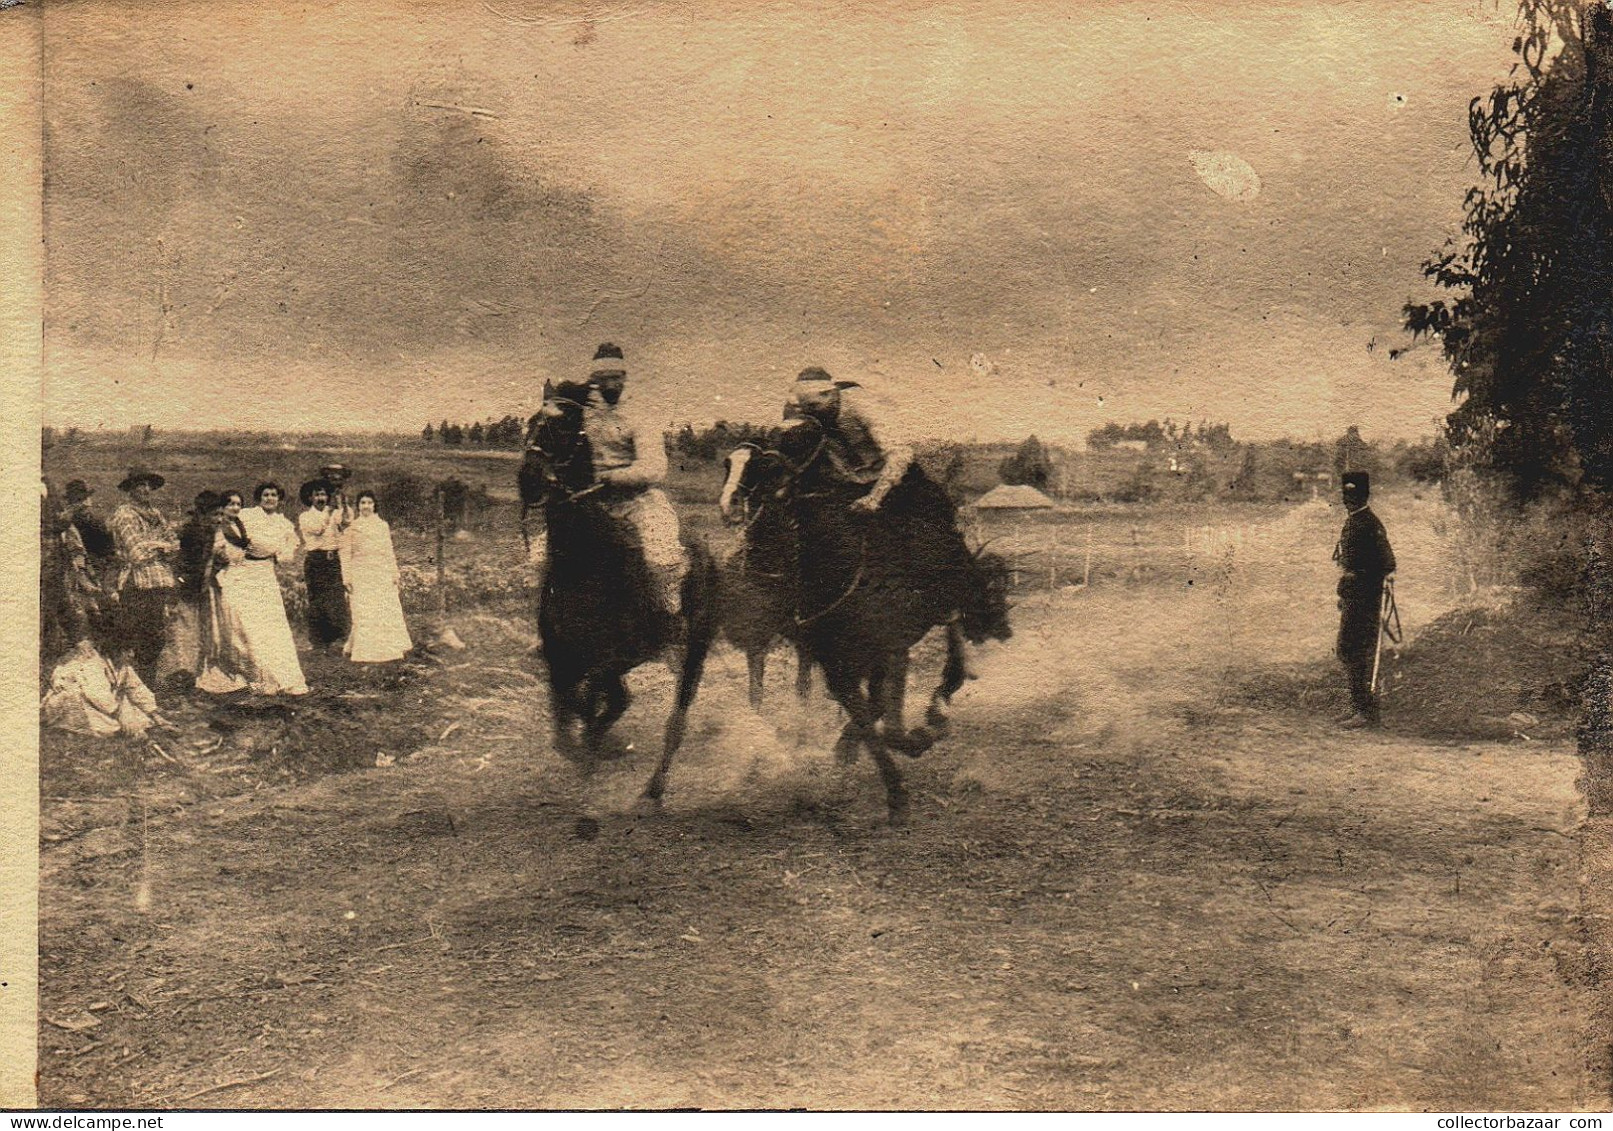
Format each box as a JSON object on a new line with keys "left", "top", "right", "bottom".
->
{"left": 729, "top": 419, "right": 1011, "bottom": 823}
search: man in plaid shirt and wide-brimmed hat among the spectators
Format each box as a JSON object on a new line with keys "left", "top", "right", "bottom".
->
{"left": 111, "top": 468, "right": 179, "bottom": 684}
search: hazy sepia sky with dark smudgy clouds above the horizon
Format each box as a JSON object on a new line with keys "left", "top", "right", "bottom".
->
{"left": 45, "top": 0, "right": 1513, "bottom": 440}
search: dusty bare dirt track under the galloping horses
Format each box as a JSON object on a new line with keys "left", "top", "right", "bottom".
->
{"left": 40, "top": 490, "right": 1610, "bottom": 1110}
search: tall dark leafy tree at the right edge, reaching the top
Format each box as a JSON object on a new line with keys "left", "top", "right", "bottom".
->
{"left": 1405, "top": 0, "right": 1613, "bottom": 500}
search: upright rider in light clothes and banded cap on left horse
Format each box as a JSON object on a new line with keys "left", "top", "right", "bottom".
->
{"left": 582, "top": 342, "right": 687, "bottom": 616}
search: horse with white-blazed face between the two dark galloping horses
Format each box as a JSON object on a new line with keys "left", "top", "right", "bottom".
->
{"left": 718, "top": 437, "right": 811, "bottom": 710}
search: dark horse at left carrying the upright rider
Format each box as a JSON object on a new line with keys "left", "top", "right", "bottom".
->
{"left": 519, "top": 381, "right": 716, "bottom": 808}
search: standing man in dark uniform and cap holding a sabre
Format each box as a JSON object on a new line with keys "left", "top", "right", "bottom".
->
{"left": 1332, "top": 471, "right": 1395, "bottom": 728}
